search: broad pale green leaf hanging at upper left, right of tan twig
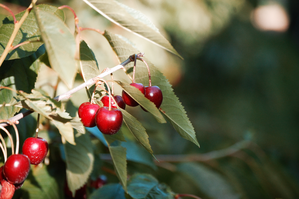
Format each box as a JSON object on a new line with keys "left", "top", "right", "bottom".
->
{"left": 34, "top": 7, "right": 77, "bottom": 88}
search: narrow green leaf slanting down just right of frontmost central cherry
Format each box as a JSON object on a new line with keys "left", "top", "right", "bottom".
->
{"left": 120, "top": 109, "right": 153, "bottom": 154}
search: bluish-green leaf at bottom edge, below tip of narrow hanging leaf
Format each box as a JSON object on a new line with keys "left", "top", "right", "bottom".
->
{"left": 128, "top": 174, "right": 174, "bottom": 199}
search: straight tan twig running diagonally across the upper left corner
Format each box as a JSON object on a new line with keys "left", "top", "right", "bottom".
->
{"left": 0, "top": 0, "right": 37, "bottom": 67}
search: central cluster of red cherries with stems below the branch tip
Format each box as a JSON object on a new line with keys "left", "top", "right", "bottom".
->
{"left": 78, "top": 57, "right": 163, "bottom": 135}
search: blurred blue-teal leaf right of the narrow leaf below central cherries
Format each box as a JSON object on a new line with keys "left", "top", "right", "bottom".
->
{"left": 121, "top": 141, "right": 157, "bottom": 169}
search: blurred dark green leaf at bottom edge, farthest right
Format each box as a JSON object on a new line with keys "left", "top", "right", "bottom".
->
{"left": 177, "top": 163, "right": 239, "bottom": 199}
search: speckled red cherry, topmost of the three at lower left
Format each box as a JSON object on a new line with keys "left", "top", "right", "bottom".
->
{"left": 22, "top": 137, "right": 48, "bottom": 165}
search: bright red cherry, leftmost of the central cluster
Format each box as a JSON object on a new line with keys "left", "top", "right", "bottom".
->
{"left": 78, "top": 102, "right": 100, "bottom": 127}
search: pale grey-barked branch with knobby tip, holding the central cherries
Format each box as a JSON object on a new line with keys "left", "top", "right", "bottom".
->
{"left": 0, "top": 53, "right": 143, "bottom": 127}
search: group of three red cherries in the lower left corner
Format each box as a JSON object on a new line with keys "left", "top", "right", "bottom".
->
{"left": 0, "top": 137, "right": 48, "bottom": 198}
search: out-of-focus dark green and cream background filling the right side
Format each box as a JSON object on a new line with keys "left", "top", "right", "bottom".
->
{"left": 1, "top": 0, "right": 299, "bottom": 199}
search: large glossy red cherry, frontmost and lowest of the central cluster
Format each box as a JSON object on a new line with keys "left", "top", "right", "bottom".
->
{"left": 96, "top": 106, "right": 123, "bottom": 135}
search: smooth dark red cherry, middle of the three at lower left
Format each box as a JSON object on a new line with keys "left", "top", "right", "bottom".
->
{"left": 3, "top": 154, "right": 30, "bottom": 184}
